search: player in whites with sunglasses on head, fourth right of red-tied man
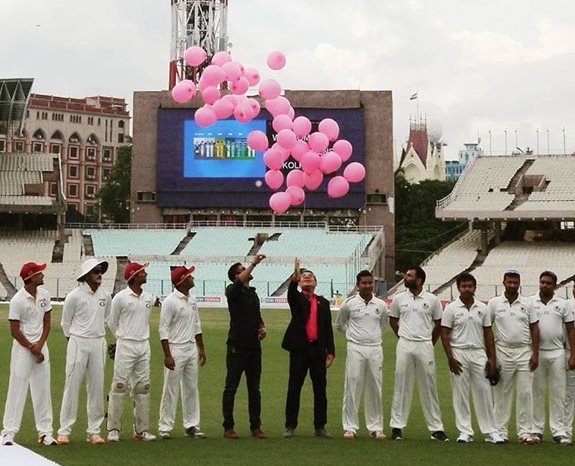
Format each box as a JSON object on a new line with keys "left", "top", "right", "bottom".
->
{"left": 488, "top": 269, "right": 539, "bottom": 445}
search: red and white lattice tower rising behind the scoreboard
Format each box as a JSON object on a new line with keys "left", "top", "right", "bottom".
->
{"left": 169, "top": 0, "right": 228, "bottom": 89}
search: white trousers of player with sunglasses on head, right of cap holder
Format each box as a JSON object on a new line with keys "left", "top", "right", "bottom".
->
{"left": 493, "top": 345, "right": 533, "bottom": 440}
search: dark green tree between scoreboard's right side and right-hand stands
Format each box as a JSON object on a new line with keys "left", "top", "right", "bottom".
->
{"left": 395, "top": 170, "right": 467, "bottom": 272}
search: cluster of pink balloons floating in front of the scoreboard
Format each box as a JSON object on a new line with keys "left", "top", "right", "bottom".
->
{"left": 172, "top": 46, "right": 365, "bottom": 213}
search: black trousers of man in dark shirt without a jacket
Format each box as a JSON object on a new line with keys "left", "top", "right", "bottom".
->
{"left": 222, "top": 345, "right": 262, "bottom": 430}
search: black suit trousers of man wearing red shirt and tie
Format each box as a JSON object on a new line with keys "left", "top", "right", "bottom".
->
{"left": 285, "top": 344, "right": 327, "bottom": 429}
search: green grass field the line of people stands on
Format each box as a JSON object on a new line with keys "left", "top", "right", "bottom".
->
{"left": 0, "top": 305, "right": 573, "bottom": 466}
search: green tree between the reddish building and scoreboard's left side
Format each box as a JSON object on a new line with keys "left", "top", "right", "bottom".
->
{"left": 90, "top": 141, "right": 132, "bottom": 223}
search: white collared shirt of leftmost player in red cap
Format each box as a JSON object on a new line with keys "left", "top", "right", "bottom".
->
{"left": 8, "top": 287, "right": 52, "bottom": 343}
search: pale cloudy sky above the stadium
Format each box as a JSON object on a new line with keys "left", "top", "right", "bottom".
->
{"left": 0, "top": 0, "right": 575, "bottom": 159}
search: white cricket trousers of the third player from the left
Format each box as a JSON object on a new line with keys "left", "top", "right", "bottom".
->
{"left": 108, "top": 339, "right": 150, "bottom": 434}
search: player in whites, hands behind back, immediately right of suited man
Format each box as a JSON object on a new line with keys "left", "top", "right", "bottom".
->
{"left": 336, "top": 270, "right": 387, "bottom": 440}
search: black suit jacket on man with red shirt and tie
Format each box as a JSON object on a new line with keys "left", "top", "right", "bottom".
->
{"left": 282, "top": 280, "right": 335, "bottom": 355}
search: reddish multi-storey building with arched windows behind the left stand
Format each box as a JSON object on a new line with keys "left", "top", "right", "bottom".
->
{"left": 0, "top": 94, "right": 130, "bottom": 214}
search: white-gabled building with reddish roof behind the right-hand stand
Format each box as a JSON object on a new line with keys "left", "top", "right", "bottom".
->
{"left": 396, "top": 122, "right": 445, "bottom": 183}
